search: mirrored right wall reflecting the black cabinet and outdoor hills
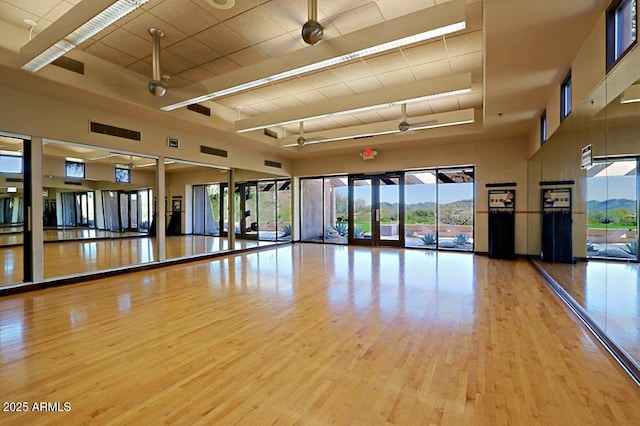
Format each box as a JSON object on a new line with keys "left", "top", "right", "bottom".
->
{"left": 528, "top": 43, "right": 640, "bottom": 371}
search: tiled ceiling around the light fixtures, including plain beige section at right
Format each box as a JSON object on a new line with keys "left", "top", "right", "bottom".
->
{"left": 0, "top": 0, "right": 608, "bottom": 157}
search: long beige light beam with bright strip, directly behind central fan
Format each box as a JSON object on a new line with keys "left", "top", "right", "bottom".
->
{"left": 162, "top": 0, "right": 466, "bottom": 111}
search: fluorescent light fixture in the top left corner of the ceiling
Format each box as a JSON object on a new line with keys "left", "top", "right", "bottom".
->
{"left": 20, "top": 0, "right": 149, "bottom": 72}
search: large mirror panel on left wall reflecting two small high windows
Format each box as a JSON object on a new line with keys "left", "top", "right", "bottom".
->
{"left": 42, "top": 141, "right": 157, "bottom": 279}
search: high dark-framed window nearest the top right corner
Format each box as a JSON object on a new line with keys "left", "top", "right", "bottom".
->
{"left": 607, "top": 0, "right": 638, "bottom": 68}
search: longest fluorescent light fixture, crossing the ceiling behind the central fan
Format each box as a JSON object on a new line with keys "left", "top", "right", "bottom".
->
{"left": 162, "top": 0, "right": 466, "bottom": 111}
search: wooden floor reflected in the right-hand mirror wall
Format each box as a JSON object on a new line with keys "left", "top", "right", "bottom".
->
{"left": 540, "top": 260, "right": 640, "bottom": 364}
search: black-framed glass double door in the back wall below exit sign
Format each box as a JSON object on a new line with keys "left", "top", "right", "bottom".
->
{"left": 348, "top": 173, "right": 404, "bottom": 246}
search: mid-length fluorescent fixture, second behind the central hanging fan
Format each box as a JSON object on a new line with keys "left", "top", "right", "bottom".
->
{"left": 234, "top": 73, "right": 471, "bottom": 133}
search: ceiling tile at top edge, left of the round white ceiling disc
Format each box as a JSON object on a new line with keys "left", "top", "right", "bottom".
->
{"left": 150, "top": 0, "right": 219, "bottom": 36}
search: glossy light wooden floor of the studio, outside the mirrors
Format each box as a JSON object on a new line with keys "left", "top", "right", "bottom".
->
{"left": 0, "top": 244, "right": 640, "bottom": 426}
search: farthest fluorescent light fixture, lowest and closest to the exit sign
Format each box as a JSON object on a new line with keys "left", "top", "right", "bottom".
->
{"left": 281, "top": 108, "right": 475, "bottom": 148}
